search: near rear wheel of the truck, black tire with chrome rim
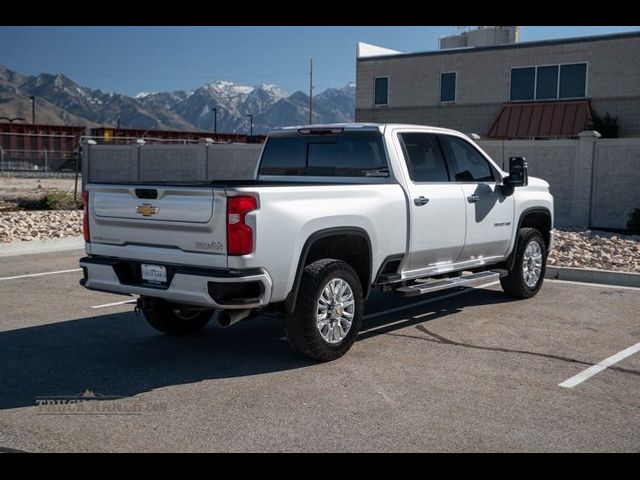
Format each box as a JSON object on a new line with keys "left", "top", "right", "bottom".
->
{"left": 284, "top": 259, "right": 364, "bottom": 362}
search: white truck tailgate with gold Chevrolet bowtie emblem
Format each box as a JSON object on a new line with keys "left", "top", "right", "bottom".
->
{"left": 87, "top": 184, "right": 227, "bottom": 267}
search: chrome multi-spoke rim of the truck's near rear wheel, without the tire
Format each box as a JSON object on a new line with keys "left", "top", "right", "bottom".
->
{"left": 316, "top": 278, "right": 356, "bottom": 345}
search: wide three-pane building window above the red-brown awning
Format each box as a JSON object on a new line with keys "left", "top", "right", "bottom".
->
{"left": 510, "top": 63, "right": 587, "bottom": 102}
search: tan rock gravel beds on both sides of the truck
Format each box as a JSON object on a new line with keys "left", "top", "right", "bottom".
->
{"left": 0, "top": 210, "right": 640, "bottom": 272}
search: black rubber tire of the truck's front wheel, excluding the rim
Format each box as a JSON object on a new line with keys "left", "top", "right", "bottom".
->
{"left": 500, "top": 228, "right": 547, "bottom": 299}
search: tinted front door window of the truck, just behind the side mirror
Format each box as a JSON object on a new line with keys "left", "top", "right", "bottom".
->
{"left": 440, "top": 135, "right": 495, "bottom": 182}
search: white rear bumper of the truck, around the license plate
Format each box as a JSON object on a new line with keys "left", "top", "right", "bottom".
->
{"left": 80, "top": 257, "right": 272, "bottom": 309}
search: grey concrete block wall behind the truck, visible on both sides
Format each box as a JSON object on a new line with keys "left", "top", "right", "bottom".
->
{"left": 83, "top": 136, "right": 640, "bottom": 232}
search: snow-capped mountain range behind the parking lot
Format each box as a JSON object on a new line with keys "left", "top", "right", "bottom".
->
{"left": 0, "top": 65, "right": 355, "bottom": 133}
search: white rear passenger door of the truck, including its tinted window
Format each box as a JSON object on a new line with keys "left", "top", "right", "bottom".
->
{"left": 398, "top": 132, "right": 466, "bottom": 271}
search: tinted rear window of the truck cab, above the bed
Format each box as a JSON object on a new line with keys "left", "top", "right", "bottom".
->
{"left": 259, "top": 133, "right": 389, "bottom": 177}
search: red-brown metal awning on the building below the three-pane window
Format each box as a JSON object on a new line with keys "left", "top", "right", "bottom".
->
{"left": 487, "top": 100, "right": 592, "bottom": 138}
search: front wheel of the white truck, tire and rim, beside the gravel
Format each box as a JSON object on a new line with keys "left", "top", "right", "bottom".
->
{"left": 500, "top": 228, "right": 547, "bottom": 299}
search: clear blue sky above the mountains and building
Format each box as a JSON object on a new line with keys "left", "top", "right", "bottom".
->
{"left": 0, "top": 26, "right": 640, "bottom": 95}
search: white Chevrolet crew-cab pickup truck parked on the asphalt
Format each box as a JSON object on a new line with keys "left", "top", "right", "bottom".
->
{"left": 80, "top": 124, "right": 553, "bottom": 361}
